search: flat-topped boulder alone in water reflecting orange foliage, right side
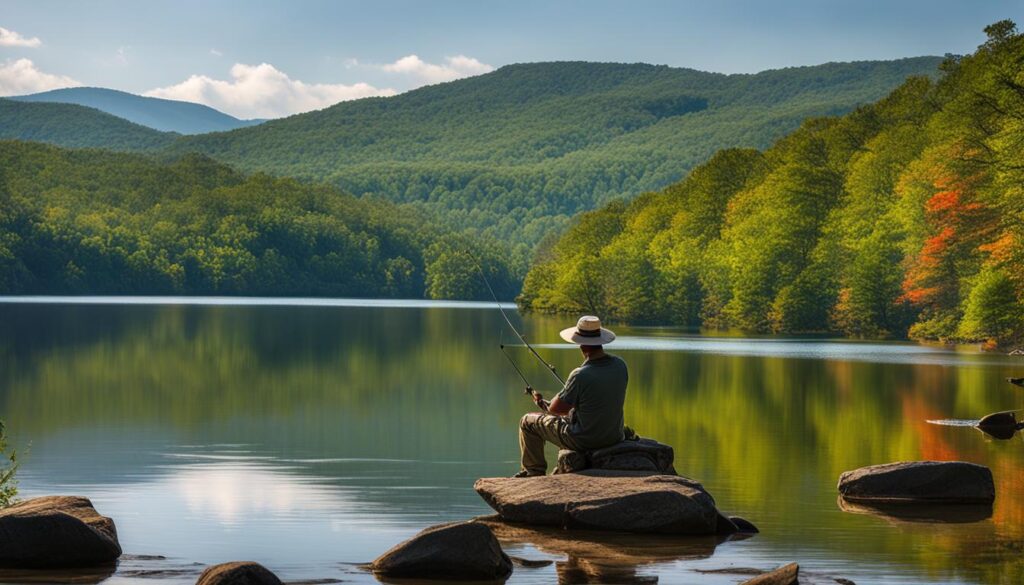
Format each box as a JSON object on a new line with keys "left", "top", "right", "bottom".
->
{"left": 839, "top": 461, "right": 995, "bottom": 504}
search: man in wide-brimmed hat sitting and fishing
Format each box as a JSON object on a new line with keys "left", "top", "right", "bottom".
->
{"left": 515, "top": 316, "right": 629, "bottom": 477}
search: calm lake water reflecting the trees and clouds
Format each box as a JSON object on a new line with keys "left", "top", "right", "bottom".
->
{"left": 0, "top": 299, "right": 1024, "bottom": 583}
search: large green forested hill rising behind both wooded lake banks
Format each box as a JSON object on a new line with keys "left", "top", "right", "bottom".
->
{"left": 175, "top": 57, "right": 940, "bottom": 243}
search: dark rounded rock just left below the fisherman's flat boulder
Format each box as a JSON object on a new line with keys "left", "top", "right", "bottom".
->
{"left": 370, "top": 521, "right": 512, "bottom": 581}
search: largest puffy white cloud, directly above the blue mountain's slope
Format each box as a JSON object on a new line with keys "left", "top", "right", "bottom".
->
{"left": 144, "top": 62, "right": 397, "bottom": 118}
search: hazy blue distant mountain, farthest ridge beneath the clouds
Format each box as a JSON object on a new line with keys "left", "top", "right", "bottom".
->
{"left": 10, "top": 87, "right": 263, "bottom": 134}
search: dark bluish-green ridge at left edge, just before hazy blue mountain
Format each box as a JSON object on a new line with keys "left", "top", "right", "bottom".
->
{"left": 0, "top": 98, "right": 177, "bottom": 152}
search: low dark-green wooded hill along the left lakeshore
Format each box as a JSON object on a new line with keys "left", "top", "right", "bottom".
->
{"left": 0, "top": 140, "right": 517, "bottom": 298}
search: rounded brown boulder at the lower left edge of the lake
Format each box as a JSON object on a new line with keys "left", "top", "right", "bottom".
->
{"left": 0, "top": 496, "right": 121, "bottom": 569}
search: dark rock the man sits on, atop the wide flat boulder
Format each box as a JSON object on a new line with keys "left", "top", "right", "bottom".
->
{"left": 555, "top": 438, "right": 676, "bottom": 475}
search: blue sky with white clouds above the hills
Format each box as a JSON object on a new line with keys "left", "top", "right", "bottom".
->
{"left": 0, "top": 0, "right": 1024, "bottom": 118}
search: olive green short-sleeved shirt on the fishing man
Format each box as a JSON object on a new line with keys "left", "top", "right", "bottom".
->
{"left": 556, "top": 353, "right": 629, "bottom": 450}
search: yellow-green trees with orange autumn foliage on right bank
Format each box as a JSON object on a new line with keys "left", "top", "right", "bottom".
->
{"left": 519, "top": 20, "right": 1024, "bottom": 345}
